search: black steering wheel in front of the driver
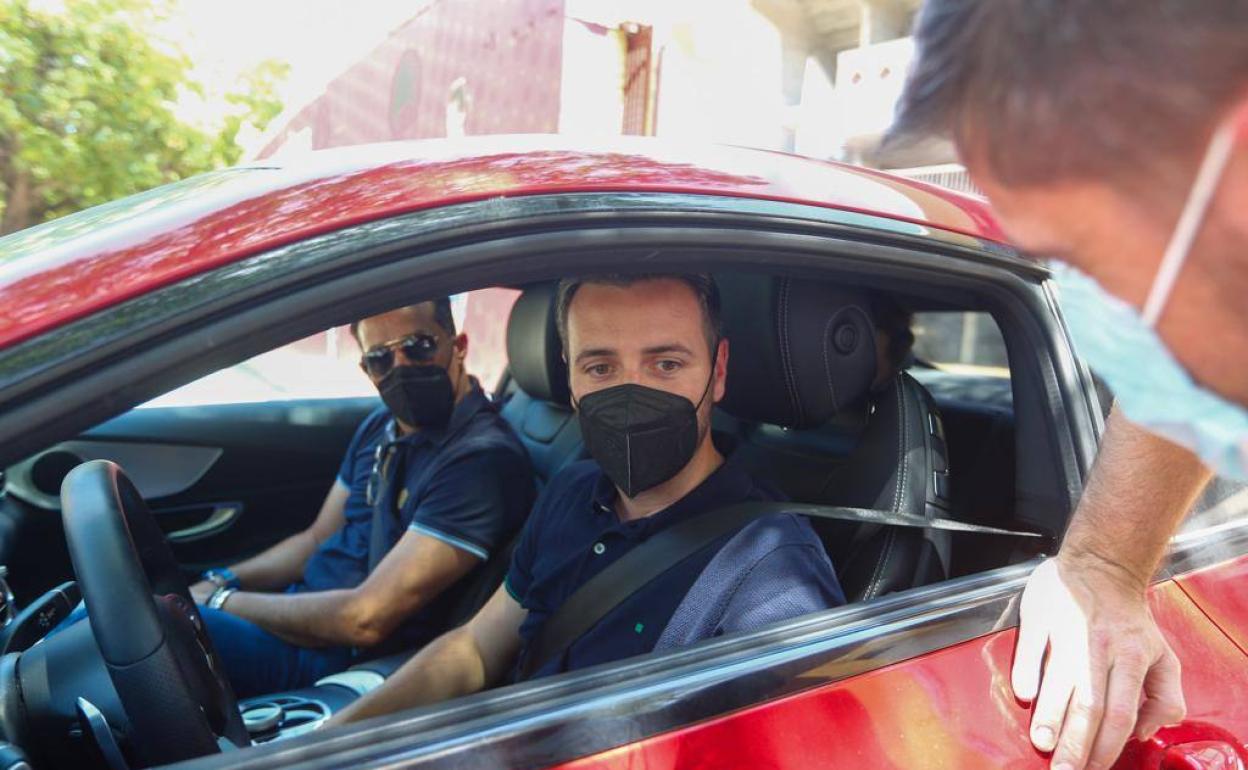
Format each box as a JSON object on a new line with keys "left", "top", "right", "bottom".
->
{"left": 61, "top": 461, "right": 251, "bottom": 764}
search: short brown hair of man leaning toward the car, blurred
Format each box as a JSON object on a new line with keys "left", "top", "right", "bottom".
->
{"left": 886, "top": 0, "right": 1248, "bottom": 185}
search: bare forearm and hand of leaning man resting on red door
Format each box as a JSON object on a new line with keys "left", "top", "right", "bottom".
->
{"left": 1012, "top": 411, "right": 1211, "bottom": 770}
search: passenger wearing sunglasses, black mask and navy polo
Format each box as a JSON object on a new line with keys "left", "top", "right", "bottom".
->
{"left": 191, "top": 298, "right": 534, "bottom": 698}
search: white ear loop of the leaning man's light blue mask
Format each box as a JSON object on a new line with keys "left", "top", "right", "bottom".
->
{"left": 1141, "top": 106, "right": 1248, "bottom": 327}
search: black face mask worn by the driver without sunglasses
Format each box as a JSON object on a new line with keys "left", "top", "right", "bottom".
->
{"left": 577, "top": 381, "right": 710, "bottom": 498}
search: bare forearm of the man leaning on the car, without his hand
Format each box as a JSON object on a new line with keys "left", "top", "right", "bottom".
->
{"left": 1058, "top": 411, "right": 1211, "bottom": 590}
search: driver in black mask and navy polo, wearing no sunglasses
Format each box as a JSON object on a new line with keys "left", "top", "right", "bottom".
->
{"left": 336, "top": 275, "right": 844, "bottom": 721}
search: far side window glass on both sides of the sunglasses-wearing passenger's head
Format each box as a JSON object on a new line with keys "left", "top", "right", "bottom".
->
{"left": 140, "top": 288, "right": 519, "bottom": 408}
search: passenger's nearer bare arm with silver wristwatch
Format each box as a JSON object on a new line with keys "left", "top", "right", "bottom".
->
{"left": 222, "top": 530, "right": 480, "bottom": 646}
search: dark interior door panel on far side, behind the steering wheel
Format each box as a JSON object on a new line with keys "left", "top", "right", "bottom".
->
{"left": 0, "top": 398, "right": 379, "bottom": 602}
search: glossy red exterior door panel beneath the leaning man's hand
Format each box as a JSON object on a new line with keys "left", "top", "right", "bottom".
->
{"left": 551, "top": 583, "right": 1248, "bottom": 770}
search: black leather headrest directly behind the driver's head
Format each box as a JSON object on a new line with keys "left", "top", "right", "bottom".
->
{"left": 716, "top": 275, "right": 876, "bottom": 428}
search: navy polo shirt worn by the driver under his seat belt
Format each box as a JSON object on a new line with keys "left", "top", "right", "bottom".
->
{"left": 504, "top": 456, "right": 845, "bottom": 678}
